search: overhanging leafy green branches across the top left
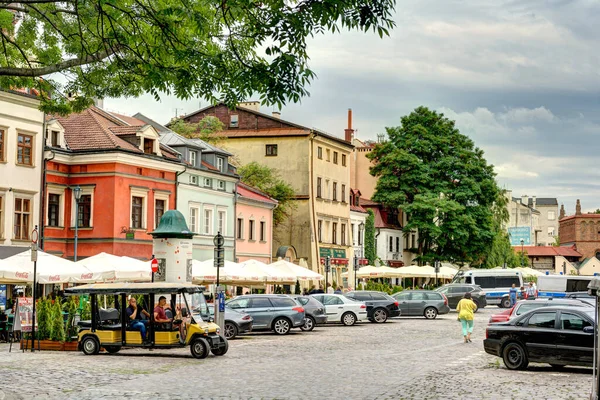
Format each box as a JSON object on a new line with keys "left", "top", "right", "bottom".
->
{"left": 0, "top": 0, "right": 395, "bottom": 113}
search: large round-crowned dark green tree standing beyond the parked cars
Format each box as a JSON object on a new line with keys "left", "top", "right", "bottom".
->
{"left": 369, "top": 107, "right": 502, "bottom": 264}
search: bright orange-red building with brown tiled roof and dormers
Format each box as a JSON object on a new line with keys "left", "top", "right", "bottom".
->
{"left": 42, "top": 107, "right": 185, "bottom": 259}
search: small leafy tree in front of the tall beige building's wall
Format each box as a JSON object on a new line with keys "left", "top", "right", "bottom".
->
{"left": 237, "top": 161, "right": 295, "bottom": 226}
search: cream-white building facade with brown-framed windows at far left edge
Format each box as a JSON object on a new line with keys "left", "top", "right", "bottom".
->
{"left": 0, "top": 91, "right": 44, "bottom": 252}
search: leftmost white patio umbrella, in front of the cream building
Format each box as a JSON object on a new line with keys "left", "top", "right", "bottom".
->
{"left": 4, "top": 250, "right": 102, "bottom": 284}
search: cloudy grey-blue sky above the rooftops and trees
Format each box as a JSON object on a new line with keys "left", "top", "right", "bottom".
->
{"left": 105, "top": 0, "right": 600, "bottom": 213}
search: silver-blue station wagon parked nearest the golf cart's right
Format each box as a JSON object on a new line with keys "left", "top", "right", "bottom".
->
{"left": 227, "top": 294, "right": 305, "bottom": 335}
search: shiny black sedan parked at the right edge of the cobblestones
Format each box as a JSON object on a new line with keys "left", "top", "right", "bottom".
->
{"left": 483, "top": 307, "right": 595, "bottom": 369}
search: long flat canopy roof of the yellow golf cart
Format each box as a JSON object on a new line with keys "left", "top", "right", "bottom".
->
{"left": 65, "top": 282, "right": 204, "bottom": 295}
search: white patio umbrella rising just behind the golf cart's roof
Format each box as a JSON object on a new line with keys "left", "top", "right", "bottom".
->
{"left": 77, "top": 252, "right": 152, "bottom": 282}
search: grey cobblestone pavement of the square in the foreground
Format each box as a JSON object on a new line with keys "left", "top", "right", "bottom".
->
{"left": 0, "top": 307, "right": 592, "bottom": 400}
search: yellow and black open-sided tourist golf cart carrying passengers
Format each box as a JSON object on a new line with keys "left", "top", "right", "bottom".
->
{"left": 65, "top": 282, "right": 229, "bottom": 358}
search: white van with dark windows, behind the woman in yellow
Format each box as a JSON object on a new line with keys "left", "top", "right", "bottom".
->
{"left": 452, "top": 269, "right": 523, "bottom": 308}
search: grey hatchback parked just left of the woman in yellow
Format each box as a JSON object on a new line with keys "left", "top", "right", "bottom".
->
{"left": 392, "top": 290, "right": 450, "bottom": 319}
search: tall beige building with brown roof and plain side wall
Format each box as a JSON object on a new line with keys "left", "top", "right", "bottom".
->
{"left": 183, "top": 103, "right": 354, "bottom": 284}
